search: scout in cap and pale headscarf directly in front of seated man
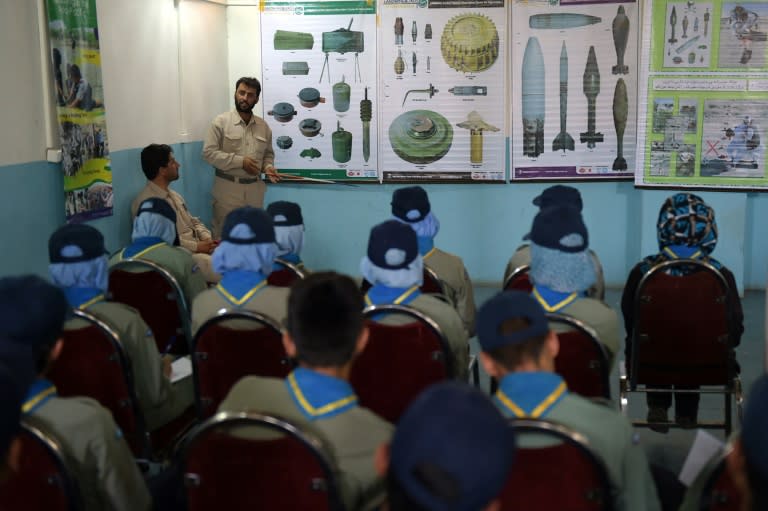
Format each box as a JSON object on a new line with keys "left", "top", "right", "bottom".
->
{"left": 109, "top": 198, "right": 207, "bottom": 303}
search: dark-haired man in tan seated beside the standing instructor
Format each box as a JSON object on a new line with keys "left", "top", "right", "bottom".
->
{"left": 131, "top": 144, "right": 221, "bottom": 283}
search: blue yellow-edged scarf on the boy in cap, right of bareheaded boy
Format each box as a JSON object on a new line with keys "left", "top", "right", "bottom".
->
{"left": 493, "top": 371, "right": 568, "bottom": 419}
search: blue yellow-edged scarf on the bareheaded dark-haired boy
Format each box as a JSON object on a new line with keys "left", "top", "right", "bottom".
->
{"left": 285, "top": 367, "right": 357, "bottom": 421}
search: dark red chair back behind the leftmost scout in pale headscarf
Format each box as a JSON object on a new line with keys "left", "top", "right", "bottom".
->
{"left": 47, "top": 309, "right": 150, "bottom": 456}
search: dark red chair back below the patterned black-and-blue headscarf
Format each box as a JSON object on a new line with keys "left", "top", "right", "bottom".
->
{"left": 628, "top": 259, "right": 735, "bottom": 390}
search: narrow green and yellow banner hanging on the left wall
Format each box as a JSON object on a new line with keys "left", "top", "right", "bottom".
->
{"left": 46, "top": 0, "right": 113, "bottom": 222}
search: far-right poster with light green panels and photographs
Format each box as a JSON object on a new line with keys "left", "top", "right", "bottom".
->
{"left": 635, "top": 1, "right": 768, "bottom": 188}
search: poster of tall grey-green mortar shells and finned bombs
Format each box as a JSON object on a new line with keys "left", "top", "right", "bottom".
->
{"left": 510, "top": 0, "right": 650, "bottom": 181}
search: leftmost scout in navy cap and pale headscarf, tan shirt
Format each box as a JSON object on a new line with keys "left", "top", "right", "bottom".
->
{"left": 48, "top": 224, "right": 194, "bottom": 431}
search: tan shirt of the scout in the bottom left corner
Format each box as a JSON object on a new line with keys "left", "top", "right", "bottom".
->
{"left": 30, "top": 397, "right": 152, "bottom": 511}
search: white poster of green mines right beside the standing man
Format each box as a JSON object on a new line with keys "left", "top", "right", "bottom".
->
{"left": 261, "top": 0, "right": 380, "bottom": 181}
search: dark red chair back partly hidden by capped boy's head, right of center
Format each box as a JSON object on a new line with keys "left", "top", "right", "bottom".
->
{"left": 547, "top": 312, "right": 611, "bottom": 399}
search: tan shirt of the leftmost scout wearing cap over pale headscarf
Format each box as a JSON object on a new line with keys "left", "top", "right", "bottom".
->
{"left": 64, "top": 302, "right": 194, "bottom": 431}
